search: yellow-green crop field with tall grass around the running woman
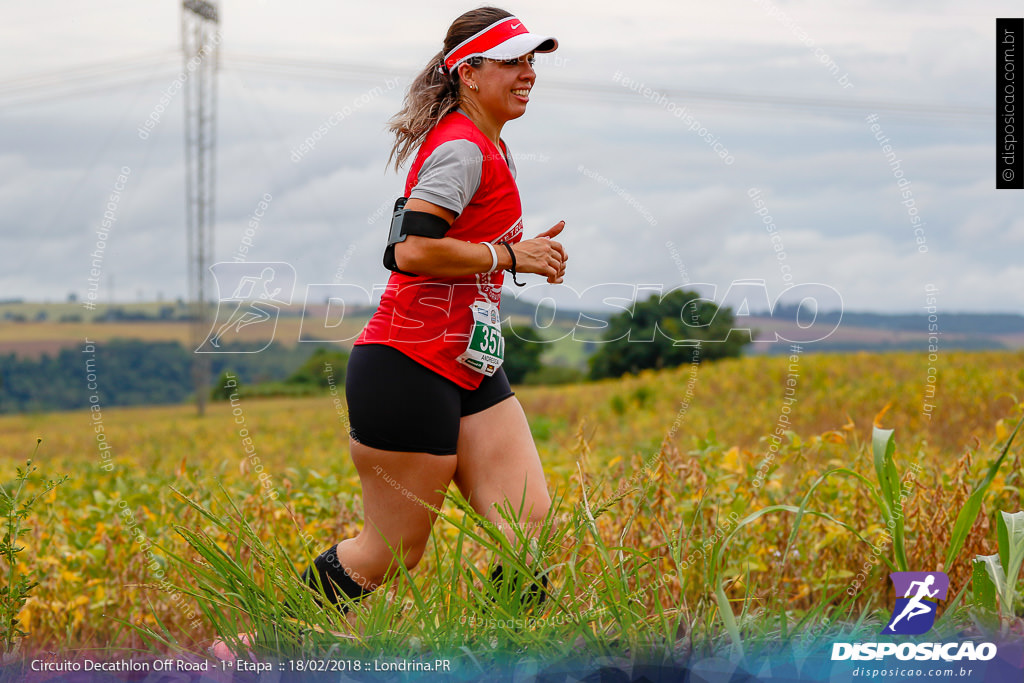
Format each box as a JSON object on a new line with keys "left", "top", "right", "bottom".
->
{"left": 0, "top": 351, "right": 1024, "bottom": 654}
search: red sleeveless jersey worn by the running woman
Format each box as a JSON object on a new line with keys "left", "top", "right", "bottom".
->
{"left": 355, "top": 112, "right": 522, "bottom": 389}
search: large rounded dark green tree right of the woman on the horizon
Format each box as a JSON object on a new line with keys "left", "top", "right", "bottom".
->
{"left": 589, "top": 290, "right": 751, "bottom": 379}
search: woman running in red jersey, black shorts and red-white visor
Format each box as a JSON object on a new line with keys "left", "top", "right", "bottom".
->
{"left": 303, "top": 7, "right": 566, "bottom": 611}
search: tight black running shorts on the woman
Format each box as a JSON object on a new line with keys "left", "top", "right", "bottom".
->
{"left": 345, "top": 344, "right": 513, "bottom": 456}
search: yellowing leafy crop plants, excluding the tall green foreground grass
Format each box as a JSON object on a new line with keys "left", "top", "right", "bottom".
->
{"left": 0, "top": 351, "right": 1024, "bottom": 650}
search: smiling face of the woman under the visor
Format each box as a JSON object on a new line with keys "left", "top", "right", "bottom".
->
{"left": 460, "top": 52, "right": 537, "bottom": 125}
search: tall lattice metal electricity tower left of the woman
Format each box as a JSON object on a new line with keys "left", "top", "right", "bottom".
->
{"left": 181, "top": 0, "right": 220, "bottom": 416}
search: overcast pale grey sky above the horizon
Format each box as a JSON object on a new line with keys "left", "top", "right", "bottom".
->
{"left": 0, "top": 0, "right": 1024, "bottom": 312}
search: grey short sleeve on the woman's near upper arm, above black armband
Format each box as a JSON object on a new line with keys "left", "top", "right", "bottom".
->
{"left": 409, "top": 140, "right": 483, "bottom": 215}
